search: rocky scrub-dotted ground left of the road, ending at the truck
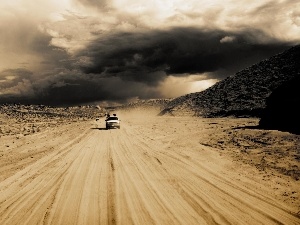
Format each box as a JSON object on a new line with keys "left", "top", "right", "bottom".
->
{"left": 0, "top": 104, "right": 105, "bottom": 138}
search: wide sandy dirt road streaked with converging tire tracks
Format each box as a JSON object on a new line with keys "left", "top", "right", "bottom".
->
{"left": 0, "top": 115, "right": 300, "bottom": 225}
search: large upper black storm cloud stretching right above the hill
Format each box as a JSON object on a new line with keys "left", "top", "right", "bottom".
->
{"left": 81, "top": 28, "right": 288, "bottom": 85}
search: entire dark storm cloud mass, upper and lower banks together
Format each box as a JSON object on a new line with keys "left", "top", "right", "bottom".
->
{"left": 0, "top": 28, "right": 288, "bottom": 105}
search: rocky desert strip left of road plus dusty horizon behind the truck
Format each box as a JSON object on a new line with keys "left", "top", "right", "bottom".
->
{"left": 0, "top": 99, "right": 170, "bottom": 138}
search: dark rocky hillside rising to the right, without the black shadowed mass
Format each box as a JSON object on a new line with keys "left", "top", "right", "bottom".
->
{"left": 160, "top": 45, "right": 300, "bottom": 117}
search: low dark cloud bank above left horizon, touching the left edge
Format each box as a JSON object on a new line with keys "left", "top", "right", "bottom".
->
{"left": 0, "top": 69, "right": 161, "bottom": 106}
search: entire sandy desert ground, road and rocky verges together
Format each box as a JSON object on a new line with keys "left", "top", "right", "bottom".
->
{"left": 0, "top": 108, "right": 300, "bottom": 225}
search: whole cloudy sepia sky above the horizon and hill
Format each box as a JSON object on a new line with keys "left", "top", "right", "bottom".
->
{"left": 0, "top": 0, "right": 300, "bottom": 106}
